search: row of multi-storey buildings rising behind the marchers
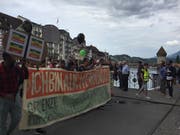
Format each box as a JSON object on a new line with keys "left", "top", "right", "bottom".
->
{"left": 0, "top": 13, "right": 108, "bottom": 63}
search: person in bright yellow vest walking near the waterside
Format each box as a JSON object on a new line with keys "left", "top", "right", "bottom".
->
{"left": 136, "top": 63, "right": 152, "bottom": 99}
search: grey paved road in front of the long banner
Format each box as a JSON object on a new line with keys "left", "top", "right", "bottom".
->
{"left": 13, "top": 85, "right": 180, "bottom": 135}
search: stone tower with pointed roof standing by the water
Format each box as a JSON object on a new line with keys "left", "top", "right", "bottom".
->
{"left": 156, "top": 46, "right": 167, "bottom": 64}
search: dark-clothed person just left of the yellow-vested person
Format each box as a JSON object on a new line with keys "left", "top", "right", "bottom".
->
{"left": 137, "top": 61, "right": 144, "bottom": 89}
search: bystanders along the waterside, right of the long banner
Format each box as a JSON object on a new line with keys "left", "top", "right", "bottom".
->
{"left": 113, "top": 60, "right": 180, "bottom": 99}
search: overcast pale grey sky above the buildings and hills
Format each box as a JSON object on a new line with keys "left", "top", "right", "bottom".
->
{"left": 0, "top": 0, "right": 180, "bottom": 58}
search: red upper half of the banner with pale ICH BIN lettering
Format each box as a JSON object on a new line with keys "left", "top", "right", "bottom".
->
{"left": 26, "top": 68, "right": 110, "bottom": 98}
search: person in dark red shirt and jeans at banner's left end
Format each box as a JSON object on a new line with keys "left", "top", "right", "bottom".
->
{"left": 0, "top": 52, "right": 22, "bottom": 135}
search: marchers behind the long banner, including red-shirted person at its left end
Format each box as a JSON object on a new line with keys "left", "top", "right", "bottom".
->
{"left": 0, "top": 52, "right": 114, "bottom": 135}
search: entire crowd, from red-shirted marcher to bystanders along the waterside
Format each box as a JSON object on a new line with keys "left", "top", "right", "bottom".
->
{"left": 0, "top": 52, "right": 180, "bottom": 135}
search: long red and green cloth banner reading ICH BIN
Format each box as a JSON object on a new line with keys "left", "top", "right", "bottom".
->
{"left": 20, "top": 67, "right": 111, "bottom": 129}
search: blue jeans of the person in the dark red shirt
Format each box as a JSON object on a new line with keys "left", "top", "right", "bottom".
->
{"left": 0, "top": 95, "right": 21, "bottom": 135}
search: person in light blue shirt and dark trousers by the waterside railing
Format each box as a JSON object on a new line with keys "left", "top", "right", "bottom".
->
{"left": 122, "top": 61, "right": 130, "bottom": 91}
